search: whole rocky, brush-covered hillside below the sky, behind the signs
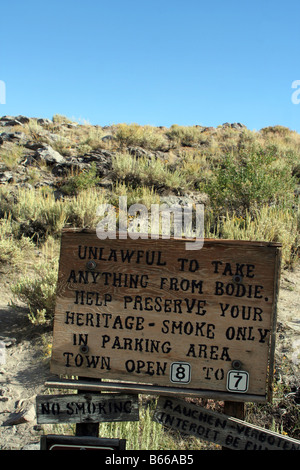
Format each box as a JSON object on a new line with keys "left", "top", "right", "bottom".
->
{"left": 0, "top": 115, "right": 300, "bottom": 449}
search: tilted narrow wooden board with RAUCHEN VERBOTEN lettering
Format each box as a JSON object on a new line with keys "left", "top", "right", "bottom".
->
{"left": 153, "top": 397, "right": 300, "bottom": 450}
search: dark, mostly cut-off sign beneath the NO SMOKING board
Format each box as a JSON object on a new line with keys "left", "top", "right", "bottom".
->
{"left": 41, "top": 434, "right": 126, "bottom": 451}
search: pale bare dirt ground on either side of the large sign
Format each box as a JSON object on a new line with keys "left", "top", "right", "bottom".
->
{"left": 0, "top": 266, "right": 300, "bottom": 450}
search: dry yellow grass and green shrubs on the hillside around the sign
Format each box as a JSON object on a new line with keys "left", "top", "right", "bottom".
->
{"left": 0, "top": 115, "right": 300, "bottom": 450}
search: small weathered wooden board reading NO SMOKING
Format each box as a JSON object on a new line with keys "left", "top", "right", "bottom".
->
{"left": 36, "top": 393, "right": 139, "bottom": 424}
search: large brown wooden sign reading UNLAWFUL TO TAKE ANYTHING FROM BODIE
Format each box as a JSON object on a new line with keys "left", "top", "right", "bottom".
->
{"left": 51, "top": 230, "right": 280, "bottom": 401}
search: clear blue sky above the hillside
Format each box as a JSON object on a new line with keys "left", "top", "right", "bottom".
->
{"left": 0, "top": 0, "right": 300, "bottom": 132}
